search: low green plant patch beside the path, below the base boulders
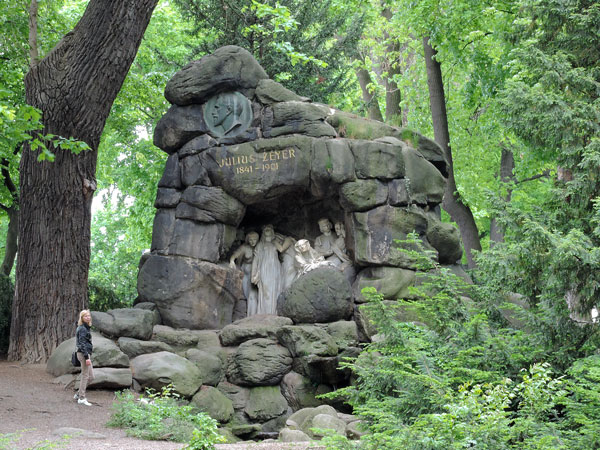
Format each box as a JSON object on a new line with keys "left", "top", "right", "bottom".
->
{"left": 107, "top": 385, "right": 224, "bottom": 450}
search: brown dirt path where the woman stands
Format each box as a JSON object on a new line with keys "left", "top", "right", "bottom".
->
{"left": 0, "top": 361, "right": 322, "bottom": 450}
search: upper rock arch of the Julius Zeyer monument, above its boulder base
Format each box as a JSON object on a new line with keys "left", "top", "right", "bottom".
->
{"left": 138, "top": 46, "right": 462, "bottom": 329}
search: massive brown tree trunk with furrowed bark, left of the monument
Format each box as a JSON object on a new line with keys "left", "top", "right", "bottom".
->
{"left": 8, "top": 0, "right": 158, "bottom": 362}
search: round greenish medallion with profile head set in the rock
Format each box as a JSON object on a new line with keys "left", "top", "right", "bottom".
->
{"left": 204, "top": 92, "right": 252, "bottom": 137}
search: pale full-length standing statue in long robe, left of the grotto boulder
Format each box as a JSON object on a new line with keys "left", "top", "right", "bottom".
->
{"left": 251, "top": 224, "right": 284, "bottom": 314}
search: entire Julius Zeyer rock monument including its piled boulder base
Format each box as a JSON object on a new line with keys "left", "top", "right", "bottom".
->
{"left": 48, "top": 46, "right": 462, "bottom": 440}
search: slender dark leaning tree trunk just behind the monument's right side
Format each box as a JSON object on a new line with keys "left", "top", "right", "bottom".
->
{"left": 423, "top": 37, "right": 481, "bottom": 268}
